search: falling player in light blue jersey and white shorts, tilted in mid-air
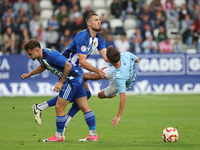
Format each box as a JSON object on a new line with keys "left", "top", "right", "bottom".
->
{"left": 83, "top": 46, "right": 139, "bottom": 127}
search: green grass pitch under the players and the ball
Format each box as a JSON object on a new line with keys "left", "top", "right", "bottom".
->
{"left": 0, "top": 94, "right": 200, "bottom": 150}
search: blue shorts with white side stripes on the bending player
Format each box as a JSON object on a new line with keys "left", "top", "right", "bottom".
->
{"left": 59, "top": 76, "right": 86, "bottom": 102}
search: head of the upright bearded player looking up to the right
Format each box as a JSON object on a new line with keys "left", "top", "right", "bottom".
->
{"left": 86, "top": 13, "right": 101, "bottom": 32}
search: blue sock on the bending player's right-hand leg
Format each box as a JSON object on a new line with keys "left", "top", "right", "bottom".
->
{"left": 84, "top": 110, "right": 96, "bottom": 130}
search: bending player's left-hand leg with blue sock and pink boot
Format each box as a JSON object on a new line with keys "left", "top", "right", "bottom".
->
{"left": 43, "top": 96, "right": 70, "bottom": 142}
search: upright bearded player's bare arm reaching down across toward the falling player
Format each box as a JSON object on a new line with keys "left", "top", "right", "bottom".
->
{"left": 79, "top": 53, "right": 105, "bottom": 79}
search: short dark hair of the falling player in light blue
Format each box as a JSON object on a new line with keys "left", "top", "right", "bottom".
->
{"left": 106, "top": 46, "right": 120, "bottom": 63}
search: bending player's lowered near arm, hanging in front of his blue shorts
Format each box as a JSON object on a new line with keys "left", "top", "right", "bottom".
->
{"left": 54, "top": 61, "right": 72, "bottom": 92}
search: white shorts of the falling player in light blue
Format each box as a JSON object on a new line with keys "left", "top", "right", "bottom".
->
{"left": 103, "top": 67, "right": 118, "bottom": 97}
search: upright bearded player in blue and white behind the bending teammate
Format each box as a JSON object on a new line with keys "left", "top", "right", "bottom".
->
{"left": 33, "top": 13, "right": 107, "bottom": 136}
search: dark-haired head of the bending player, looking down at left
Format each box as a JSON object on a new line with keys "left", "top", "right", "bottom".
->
{"left": 24, "top": 39, "right": 41, "bottom": 60}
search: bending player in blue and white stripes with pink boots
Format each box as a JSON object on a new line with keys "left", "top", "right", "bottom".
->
{"left": 21, "top": 39, "right": 98, "bottom": 142}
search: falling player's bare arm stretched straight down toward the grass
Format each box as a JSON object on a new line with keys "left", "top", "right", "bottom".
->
{"left": 111, "top": 92, "right": 126, "bottom": 127}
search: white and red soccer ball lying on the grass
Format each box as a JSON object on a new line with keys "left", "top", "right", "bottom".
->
{"left": 162, "top": 127, "right": 178, "bottom": 142}
